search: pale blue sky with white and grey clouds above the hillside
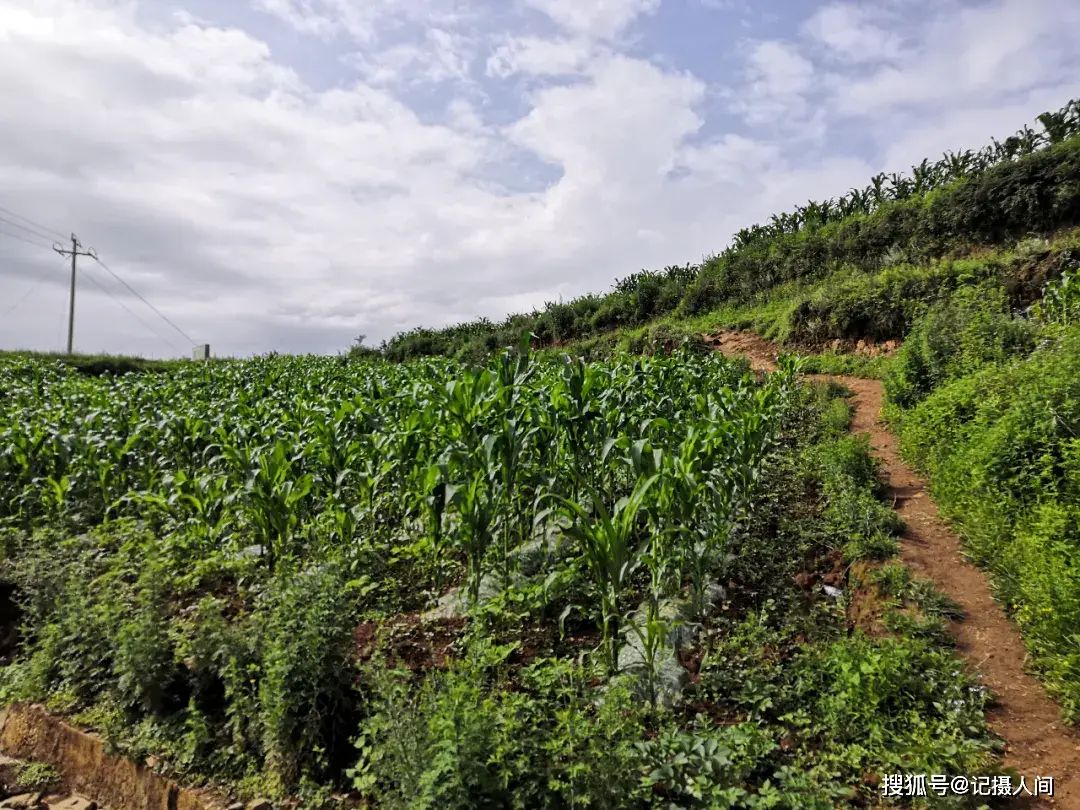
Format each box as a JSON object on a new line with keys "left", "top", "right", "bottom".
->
{"left": 0, "top": 0, "right": 1080, "bottom": 356}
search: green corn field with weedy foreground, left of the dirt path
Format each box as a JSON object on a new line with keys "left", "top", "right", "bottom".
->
{"left": 0, "top": 342, "right": 994, "bottom": 810}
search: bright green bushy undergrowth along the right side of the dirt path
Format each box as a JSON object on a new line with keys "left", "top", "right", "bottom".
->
{"left": 890, "top": 324, "right": 1080, "bottom": 716}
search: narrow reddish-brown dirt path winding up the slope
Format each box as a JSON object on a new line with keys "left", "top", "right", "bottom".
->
{"left": 708, "top": 333, "right": 1080, "bottom": 810}
